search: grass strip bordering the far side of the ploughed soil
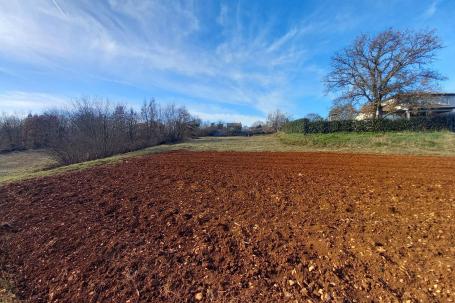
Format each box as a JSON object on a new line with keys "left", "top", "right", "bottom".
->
{"left": 0, "top": 132, "right": 455, "bottom": 184}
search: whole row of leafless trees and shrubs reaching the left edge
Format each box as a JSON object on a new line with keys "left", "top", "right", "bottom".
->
{"left": 0, "top": 99, "right": 200, "bottom": 164}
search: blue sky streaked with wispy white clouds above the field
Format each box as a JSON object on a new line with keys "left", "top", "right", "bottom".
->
{"left": 0, "top": 0, "right": 455, "bottom": 124}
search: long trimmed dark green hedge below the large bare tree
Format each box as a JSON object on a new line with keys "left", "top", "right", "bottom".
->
{"left": 282, "top": 115, "right": 455, "bottom": 134}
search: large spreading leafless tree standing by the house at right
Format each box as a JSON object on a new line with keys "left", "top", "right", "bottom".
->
{"left": 324, "top": 29, "right": 444, "bottom": 118}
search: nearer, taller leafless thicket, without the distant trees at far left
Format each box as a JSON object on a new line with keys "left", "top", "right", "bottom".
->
{"left": 50, "top": 98, "right": 199, "bottom": 164}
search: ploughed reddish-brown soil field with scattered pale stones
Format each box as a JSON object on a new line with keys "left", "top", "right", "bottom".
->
{"left": 0, "top": 152, "right": 455, "bottom": 302}
